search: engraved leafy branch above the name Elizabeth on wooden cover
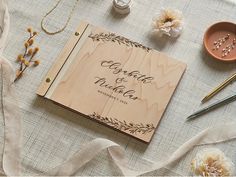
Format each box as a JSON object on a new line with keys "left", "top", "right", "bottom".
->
{"left": 88, "top": 33, "right": 151, "bottom": 52}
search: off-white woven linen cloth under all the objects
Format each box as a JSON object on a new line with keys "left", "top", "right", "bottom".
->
{"left": 0, "top": 0, "right": 236, "bottom": 176}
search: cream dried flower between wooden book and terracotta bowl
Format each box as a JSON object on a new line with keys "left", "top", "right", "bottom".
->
{"left": 153, "top": 9, "right": 183, "bottom": 37}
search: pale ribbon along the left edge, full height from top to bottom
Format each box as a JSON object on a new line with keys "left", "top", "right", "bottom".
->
{"left": 0, "top": 0, "right": 21, "bottom": 176}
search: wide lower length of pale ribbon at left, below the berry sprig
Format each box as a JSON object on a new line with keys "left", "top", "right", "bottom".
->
{"left": 0, "top": 57, "right": 21, "bottom": 176}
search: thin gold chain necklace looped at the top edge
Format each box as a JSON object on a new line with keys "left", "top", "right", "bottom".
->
{"left": 41, "top": 0, "right": 79, "bottom": 35}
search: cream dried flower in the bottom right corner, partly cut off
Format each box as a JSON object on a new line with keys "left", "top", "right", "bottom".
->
{"left": 191, "top": 148, "right": 234, "bottom": 177}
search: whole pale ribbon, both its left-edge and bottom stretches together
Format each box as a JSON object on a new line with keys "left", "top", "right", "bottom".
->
{"left": 0, "top": 0, "right": 236, "bottom": 176}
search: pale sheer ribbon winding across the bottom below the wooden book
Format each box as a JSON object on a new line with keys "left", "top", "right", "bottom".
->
{"left": 45, "top": 122, "right": 236, "bottom": 176}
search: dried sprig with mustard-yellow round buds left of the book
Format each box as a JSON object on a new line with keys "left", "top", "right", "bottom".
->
{"left": 14, "top": 28, "right": 40, "bottom": 82}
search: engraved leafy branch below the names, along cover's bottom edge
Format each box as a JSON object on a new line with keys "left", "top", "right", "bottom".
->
{"left": 89, "top": 113, "right": 155, "bottom": 134}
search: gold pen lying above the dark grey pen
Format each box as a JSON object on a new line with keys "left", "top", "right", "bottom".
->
{"left": 202, "top": 73, "right": 236, "bottom": 103}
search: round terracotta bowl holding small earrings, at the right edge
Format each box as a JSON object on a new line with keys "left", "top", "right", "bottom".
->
{"left": 204, "top": 22, "right": 236, "bottom": 62}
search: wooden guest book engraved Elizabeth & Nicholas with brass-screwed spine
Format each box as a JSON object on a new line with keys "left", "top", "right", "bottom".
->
{"left": 37, "top": 22, "right": 186, "bottom": 143}
